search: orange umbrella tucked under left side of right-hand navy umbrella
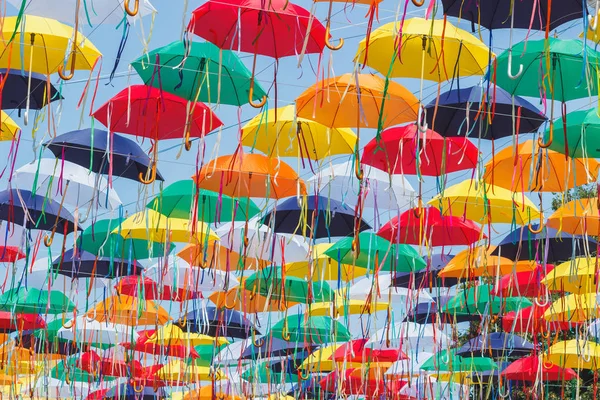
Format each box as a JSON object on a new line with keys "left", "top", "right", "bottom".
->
{"left": 438, "top": 246, "right": 536, "bottom": 279}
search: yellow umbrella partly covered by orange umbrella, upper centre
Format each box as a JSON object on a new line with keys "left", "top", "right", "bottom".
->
{"left": 242, "top": 106, "right": 356, "bottom": 160}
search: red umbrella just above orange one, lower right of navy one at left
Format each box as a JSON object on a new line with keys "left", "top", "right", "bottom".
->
{"left": 115, "top": 275, "right": 201, "bottom": 301}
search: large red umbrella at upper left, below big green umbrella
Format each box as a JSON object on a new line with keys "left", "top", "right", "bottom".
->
{"left": 93, "top": 85, "right": 223, "bottom": 140}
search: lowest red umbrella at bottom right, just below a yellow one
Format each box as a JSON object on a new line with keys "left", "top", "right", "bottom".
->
{"left": 500, "top": 355, "right": 579, "bottom": 382}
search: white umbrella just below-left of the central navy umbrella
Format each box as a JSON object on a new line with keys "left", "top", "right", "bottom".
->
{"left": 216, "top": 220, "right": 308, "bottom": 265}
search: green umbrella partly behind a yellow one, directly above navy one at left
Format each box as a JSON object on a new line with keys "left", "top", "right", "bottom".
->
{"left": 78, "top": 218, "right": 175, "bottom": 260}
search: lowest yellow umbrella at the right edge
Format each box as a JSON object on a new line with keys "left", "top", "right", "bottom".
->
{"left": 544, "top": 339, "right": 600, "bottom": 369}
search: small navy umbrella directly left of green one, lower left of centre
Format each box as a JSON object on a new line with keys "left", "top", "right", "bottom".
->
{"left": 175, "top": 307, "right": 260, "bottom": 339}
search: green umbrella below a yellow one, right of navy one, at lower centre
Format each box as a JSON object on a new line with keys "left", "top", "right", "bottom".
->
{"left": 265, "top": 314, "right": 352, "bottom": 344}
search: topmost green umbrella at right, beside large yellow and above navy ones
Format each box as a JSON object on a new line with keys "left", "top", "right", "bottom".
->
{"left": 491, "top": 38, "right": 599, "bottom": 101}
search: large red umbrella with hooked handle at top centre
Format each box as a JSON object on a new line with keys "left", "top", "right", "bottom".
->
{"left": 188, "top": 0, "right": 331, "bottom": 108}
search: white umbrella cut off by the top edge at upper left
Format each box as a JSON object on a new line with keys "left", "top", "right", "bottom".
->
{"left": 8, "top": 0, "right": 156, "bottom": 26}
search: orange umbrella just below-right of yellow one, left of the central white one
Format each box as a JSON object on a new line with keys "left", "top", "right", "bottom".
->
{"left": 177, "top": 241, "right": 269, "bottom": 271}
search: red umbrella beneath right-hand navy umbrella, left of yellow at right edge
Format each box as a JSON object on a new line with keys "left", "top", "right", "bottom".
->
{"left": 494, "top": 264, "right": 554, "bottom": 297}
